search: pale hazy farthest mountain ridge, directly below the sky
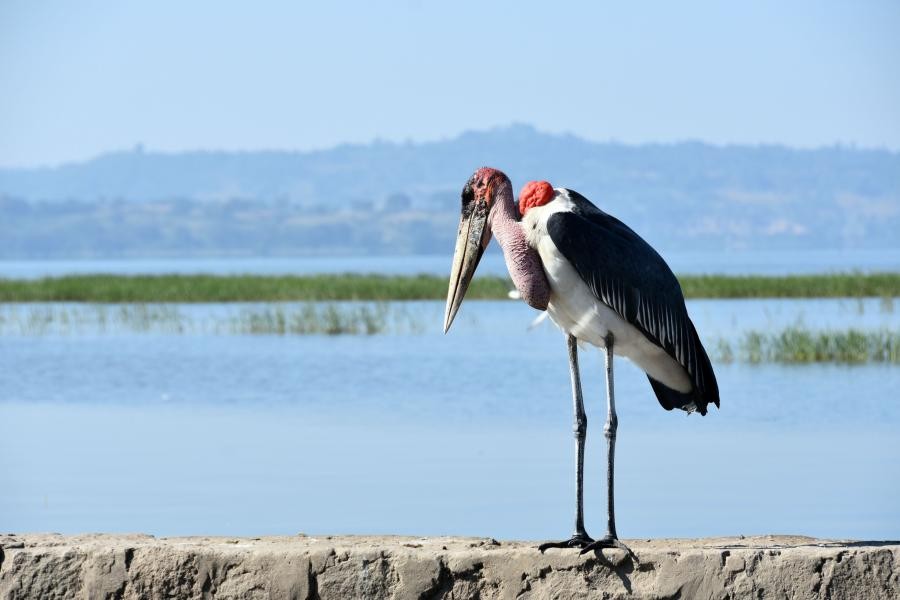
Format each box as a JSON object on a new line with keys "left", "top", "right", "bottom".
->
{"left": 0, "top": 125, "right": 900, "bottom": 202}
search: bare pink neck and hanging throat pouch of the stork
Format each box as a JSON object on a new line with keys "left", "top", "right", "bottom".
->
{"left": 490, "top": 178, "right": 550, "bottom": 310}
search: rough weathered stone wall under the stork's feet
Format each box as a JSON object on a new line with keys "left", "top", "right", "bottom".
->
{"left": 0, "top": 534, "right": 900, "bottom": 600}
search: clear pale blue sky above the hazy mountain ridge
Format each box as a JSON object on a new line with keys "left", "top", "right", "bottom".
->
{"left": 0, "top": 0, "right": 900, "bottom": 167}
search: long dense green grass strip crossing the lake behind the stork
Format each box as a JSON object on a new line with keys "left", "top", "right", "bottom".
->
{"left": 0, "top": 273, "right": 900, "bottom": 303}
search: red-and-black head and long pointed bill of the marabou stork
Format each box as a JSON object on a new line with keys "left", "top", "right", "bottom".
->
{"left": 444, "top": 167, "right": 512, "bottom": 333}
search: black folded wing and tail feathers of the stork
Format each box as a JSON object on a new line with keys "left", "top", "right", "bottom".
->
{"left": 547, "top": 190, "right": 719, "bottom": 414}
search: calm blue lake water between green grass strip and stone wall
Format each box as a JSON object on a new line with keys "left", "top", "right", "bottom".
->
{"left": 0, "top": 298, "right": 900, "bottom": 539}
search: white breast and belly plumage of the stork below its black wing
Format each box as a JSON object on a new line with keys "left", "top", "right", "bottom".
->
{"left": 537, "top": 235, "right": 693, "bottom": 393}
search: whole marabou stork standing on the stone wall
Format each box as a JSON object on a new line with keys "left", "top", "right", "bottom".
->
{"left": 444, "top": 167, "right": 719, "bottom": 556}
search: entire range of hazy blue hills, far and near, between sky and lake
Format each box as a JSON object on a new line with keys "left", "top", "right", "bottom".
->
{"left": 0, "top": 125, "right": 900, "bottom": 258}
